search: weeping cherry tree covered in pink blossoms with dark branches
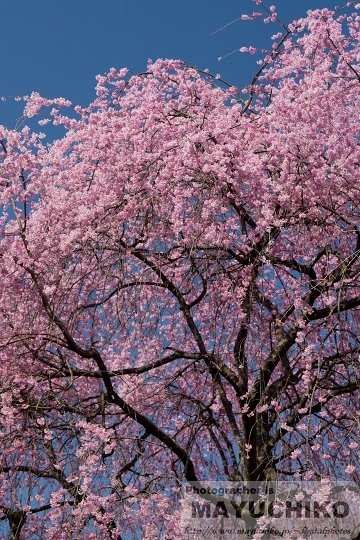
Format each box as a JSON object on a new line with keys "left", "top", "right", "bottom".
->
{"left": 0, "top": 5, "right": 360, "bottom": 540}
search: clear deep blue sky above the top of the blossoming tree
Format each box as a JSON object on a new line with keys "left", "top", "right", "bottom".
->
{"left": 0, "top": 0, "right": 339, "bottom": 128}
